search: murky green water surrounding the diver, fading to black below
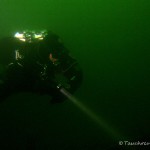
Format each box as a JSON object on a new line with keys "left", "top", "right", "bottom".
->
{"left": 0, "top": 0, "right": 150, "bottom": 150}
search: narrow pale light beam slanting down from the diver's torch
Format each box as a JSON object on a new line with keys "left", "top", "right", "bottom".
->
{"left": 60, "top": 87, "right": 123, "bottom": 140}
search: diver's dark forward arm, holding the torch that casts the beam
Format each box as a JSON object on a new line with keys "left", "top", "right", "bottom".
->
{"left": 47, "top": 59, "right": 83, "bottom": 103}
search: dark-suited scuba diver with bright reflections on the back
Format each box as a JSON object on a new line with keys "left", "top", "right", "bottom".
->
{"left": 0, "top": 30, "right": 82, "bottom": 103}
